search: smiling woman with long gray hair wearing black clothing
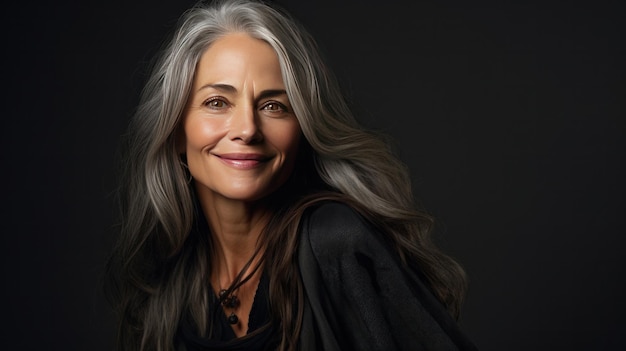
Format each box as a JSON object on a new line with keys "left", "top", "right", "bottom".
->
{"left": 109, "top": 0, "right": 473, "bottom": 350}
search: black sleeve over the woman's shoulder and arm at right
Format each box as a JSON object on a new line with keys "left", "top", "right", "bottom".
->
{"left": 298, "top": 203, "right": 475, "bottom": 350}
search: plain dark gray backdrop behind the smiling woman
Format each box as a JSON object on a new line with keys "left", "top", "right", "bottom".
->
{"left": 0, "top": 0, "right": 626, "bottom": 350}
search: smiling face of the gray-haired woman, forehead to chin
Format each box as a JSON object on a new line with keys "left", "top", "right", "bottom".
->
{"left": 183, "top": 34, "right": 301, "bottom": 201}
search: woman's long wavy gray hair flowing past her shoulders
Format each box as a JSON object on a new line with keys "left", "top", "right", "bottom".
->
{"left": 109, "top": 0, "right": 465, "bottom": 350}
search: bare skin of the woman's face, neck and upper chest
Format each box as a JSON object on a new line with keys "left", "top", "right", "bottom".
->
{"left": 181, "top": 33, "right": 301, "bottom": 336}
